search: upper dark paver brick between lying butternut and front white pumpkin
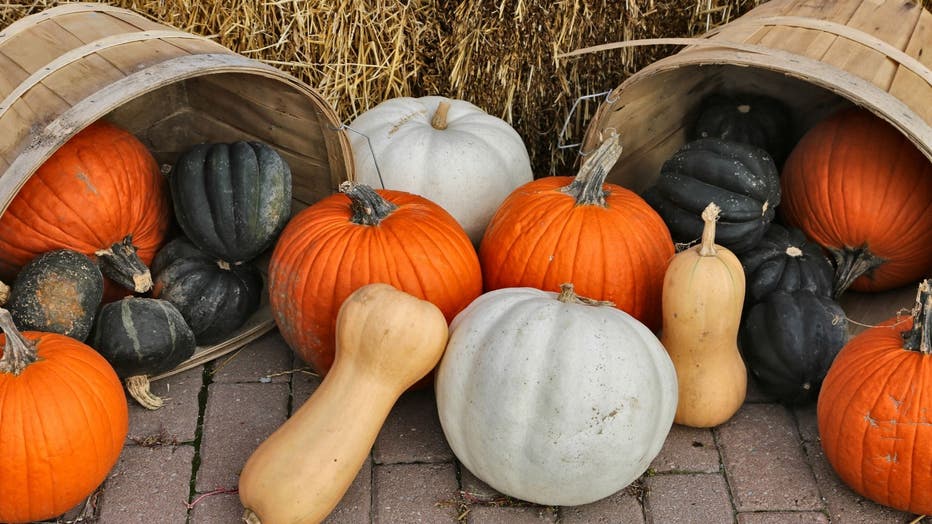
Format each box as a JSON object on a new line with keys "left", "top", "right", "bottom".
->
{"left": 372, "top": 389, "right": 453, "bottom": 464}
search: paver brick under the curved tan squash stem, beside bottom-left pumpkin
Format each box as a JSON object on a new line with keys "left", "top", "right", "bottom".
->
{"left": 126, "top": 367, "right": 204, "bottom": 443}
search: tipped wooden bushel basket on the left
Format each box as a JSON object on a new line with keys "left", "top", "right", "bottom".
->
{"left": 0, "top": 3, "right": 352, "bottom": 378}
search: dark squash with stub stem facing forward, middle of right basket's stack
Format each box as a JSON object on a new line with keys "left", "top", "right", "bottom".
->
{"left": 738, "top": 223, "right": 835, "bottom": 303}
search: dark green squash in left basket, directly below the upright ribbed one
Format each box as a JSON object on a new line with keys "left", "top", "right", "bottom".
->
{"left": 152, "top": 237, "right": 262, "bottom": 345}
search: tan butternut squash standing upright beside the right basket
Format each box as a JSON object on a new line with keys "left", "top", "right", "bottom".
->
{"left": 660, "top": 203, "right": 747, "bottom": 427}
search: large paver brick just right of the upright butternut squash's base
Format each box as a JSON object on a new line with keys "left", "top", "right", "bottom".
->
{"left": 716, "top": 404, "right": 823, "bottom": 511}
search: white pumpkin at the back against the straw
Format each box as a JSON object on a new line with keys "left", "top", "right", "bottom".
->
{"left": 348, "top": 96, "right": 534, "bottom": 245}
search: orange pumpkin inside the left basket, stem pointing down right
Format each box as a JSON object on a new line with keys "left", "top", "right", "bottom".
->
{"left": 0, "top": 120, "right": 171, "bottom": 299}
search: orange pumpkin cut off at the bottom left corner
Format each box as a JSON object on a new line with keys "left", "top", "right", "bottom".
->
{"left": 0, "top": 309, "right": 128, "bottom": 523}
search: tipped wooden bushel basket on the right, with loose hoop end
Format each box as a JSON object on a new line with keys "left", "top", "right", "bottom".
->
{"left": 576, "top": 0, "right": 932, "bottom": 333}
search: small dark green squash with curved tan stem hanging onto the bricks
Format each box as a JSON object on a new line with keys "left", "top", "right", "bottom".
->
{"left": 91, "top": 297, "right": 197, "bottom": 409}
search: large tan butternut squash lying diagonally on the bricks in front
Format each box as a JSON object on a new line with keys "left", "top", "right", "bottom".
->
{"left": 239, "top": 284, "right": 448, "bottom": 524}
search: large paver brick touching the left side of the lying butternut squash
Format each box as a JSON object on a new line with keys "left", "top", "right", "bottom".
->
{"left": 195, "top": 383, "right": 289, "bottom": 493}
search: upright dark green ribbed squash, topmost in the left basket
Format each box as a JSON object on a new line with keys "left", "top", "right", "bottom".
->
{"left": 169, "top": 142, "right": 291, "bottom": 263}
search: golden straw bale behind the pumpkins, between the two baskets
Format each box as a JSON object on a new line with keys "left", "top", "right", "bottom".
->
{"left": 0, "top": 0, "right": 932, "bottom": 176}
